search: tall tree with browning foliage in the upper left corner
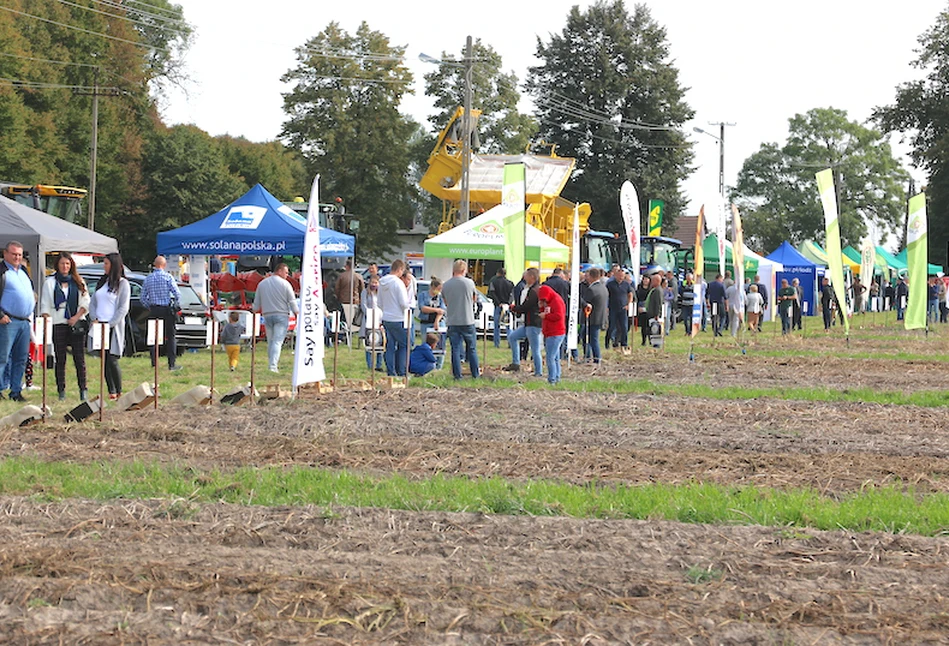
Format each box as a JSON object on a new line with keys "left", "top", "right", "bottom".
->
{"left": 0, "top": 0, "right": 191, "bottom": 246}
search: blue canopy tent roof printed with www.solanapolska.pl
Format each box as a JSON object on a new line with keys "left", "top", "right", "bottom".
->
{"left": 158, "top": 184, "right": 356, "bottom": 257}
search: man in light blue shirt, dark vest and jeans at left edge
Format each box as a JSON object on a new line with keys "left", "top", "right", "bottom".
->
{"left": 0, "top": 240, "right": 36, "bottom": 402}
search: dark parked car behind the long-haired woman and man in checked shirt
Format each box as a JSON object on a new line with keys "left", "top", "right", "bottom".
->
{"left": 78, "top": 265, "right": 209, "bottom": 356}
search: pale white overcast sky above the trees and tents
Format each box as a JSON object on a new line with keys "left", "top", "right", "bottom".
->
{"left": 162, "top": 0, "right": 949, "bottom": 233}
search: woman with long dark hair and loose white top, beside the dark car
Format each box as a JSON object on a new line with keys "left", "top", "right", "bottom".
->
{"left": 89, "top": 253, "right": 132, "bottom": 399}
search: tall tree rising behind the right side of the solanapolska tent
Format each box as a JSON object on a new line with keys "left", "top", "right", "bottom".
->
{"left": 281, "top": 22, "right": 417, "bottom": 255}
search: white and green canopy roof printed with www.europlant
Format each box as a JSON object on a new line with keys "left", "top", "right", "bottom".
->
{"left": 423, "top": 204, "right": 570, "bottom": 278}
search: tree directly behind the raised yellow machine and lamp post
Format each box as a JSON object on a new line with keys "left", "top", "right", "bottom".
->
{"left": 425, "top": 38, "right": 537, "bottom": 154}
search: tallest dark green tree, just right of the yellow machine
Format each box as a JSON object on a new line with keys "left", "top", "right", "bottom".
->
{"left": 527, "top": 0, "right": 693, "bottom": 231}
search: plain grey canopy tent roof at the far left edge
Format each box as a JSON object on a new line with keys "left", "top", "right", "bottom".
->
{"left": 0, "top": 196, "right": 119, "bottom": 286}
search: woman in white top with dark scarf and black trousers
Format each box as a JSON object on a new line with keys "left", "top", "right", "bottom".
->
{"left": 40, "top": 251, "right": 89, "bottom": 401}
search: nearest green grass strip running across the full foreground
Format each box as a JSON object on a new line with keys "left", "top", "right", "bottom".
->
{"left": 0, "top": 458, "right": 949, "bottom": 536}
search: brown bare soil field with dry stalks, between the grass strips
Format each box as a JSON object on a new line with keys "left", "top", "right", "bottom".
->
{"left": 0, "top": 354, "right": 949, "bottom": 644}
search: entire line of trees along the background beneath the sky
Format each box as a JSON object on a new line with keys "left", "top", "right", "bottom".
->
{"left": 0, "top": 0, "right": 949, "bottom": 262}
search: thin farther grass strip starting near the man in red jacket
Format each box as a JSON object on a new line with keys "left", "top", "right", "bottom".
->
{"left": 424, "top": 374, "right": 949, "bottom": 408}
